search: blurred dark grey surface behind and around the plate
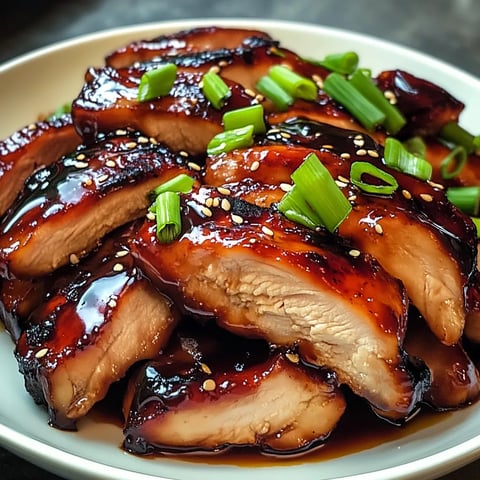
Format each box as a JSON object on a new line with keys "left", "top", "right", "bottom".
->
{"left": 0, "top": 0, "right": 480, "bottom": 480}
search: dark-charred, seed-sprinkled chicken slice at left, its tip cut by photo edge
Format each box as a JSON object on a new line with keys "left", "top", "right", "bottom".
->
{"left": 0, "top": 131, "right": 195, "bottom": 277}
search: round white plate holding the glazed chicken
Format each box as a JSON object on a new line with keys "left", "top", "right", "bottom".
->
{"left": 0, "top": 19, "right": 480, "bottom": 480}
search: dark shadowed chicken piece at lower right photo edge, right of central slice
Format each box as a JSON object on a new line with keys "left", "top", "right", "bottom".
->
{"left": 404, "top": 309, "right": 480, "bottom": 410}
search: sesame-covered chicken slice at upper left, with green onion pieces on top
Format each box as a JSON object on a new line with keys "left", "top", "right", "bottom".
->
{"left": 72, "top": 65, "right": 253, "bottom": 155}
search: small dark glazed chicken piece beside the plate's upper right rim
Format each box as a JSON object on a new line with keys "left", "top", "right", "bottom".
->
{"left": 376, "top": 70, "right": 464, "bottom": 136}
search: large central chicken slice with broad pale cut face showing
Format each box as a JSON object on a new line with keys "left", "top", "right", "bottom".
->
{"left": 131, "top": 187, "right": 430, "bottom": 421}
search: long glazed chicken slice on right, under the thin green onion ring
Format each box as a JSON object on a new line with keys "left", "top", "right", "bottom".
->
{"left": 205, "top": 121, "right": 476, "bottom": 345}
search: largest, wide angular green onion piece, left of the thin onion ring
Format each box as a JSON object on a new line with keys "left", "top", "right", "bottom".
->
{"left": 278, "top": 153, "right": 352, "bottom": 232}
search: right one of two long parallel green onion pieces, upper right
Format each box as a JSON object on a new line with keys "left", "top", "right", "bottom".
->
{"left": 349, "top": 70, "right": 407, "bottom": 135}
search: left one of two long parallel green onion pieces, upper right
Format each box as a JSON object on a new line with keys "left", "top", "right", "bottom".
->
{"left": 323, "top": 72, "right": 385, "bottom": 130}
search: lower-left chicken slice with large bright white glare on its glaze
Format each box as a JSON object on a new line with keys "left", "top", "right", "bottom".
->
{"left": 16, "top": 234, "right": 176, "bottom": 429}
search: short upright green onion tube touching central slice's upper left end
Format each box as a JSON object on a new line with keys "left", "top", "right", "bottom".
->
{"left": 155, "top": 192, "right": 182, "bottom": 243}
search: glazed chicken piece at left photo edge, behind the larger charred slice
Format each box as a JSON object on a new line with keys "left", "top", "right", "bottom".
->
{"left": 0, "top": 115, "right": 81, "bottom": 216}
